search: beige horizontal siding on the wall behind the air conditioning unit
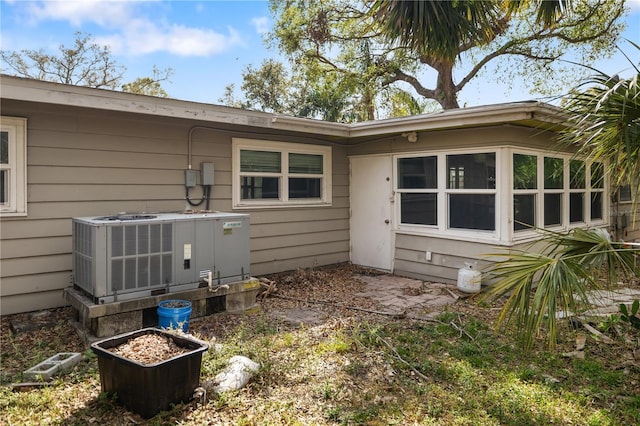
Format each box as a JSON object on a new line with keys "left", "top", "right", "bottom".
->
{"left": 0, "top": 99, "right": 349, "bottom": 315}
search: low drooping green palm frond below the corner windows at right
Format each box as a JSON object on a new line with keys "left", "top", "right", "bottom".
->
{"left": 484, "top": 229, "right": 638, "bottom": 349}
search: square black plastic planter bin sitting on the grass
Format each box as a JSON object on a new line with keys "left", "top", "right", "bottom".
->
{"left": 91, "top": 328, "right": 209, "bottom": 419}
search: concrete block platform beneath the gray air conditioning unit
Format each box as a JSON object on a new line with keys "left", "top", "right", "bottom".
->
{"left": 64, "top": 278, "right": 260, "bottom": 338}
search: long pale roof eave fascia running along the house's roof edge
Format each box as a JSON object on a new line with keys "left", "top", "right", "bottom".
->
{"left": 0, "top": 75, "right": 564, "bottom": 138}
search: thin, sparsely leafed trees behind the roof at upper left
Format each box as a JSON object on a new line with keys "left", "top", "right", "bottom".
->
{"left": 0, "top": 32, "right": 173, "bottom": 97}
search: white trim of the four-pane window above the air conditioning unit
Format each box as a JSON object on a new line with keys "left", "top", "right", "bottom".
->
{"left": 232, "top": 138, "right": 333, "bottom": 209}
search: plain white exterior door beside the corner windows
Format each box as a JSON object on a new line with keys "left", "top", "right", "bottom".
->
{"left": 349, "top": 155, "right": 393, "bottom": 271}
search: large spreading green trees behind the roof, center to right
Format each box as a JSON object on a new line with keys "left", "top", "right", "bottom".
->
{"left": 229, "top": 0, "right": 624, "bottom": 121}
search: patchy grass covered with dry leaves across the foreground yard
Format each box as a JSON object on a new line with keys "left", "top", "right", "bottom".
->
{"left": 0, "top": 265, "right": 640, "bottom": 425}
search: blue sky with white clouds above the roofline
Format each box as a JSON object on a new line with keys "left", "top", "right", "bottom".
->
{"left": 0, "top": 0, "right": 640, "bottom": 110}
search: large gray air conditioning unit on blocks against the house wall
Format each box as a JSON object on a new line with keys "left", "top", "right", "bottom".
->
{"left": 72, "top": 213, "right": 250, "bottom": 304}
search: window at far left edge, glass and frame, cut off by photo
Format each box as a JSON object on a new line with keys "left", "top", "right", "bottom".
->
{"left": 0, "top": 117, "right": 27, "bottom": 216}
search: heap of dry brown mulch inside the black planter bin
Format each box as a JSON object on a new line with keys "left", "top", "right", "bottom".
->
{"left": 107, "top": 334, "right": 191, "bottom": 364}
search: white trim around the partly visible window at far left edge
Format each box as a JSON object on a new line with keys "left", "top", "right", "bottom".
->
{"left": 0, "top": 116, "right": 27, "bottom": 217}
